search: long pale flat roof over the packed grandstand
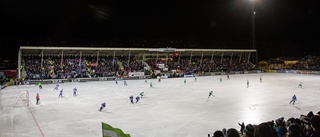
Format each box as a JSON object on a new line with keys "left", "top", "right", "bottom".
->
{"left": 20, "top": 46, "right": 256, "bottom": 56}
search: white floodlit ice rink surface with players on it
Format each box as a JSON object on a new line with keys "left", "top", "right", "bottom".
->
{"left": 0, "top": 73, "right": 320, "bottom": 137}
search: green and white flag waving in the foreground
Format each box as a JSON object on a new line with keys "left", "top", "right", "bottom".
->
{"left": 102, "top": 122, "right": 131, "bottom": 137}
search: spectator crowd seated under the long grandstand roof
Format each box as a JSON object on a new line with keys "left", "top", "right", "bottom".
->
{"left": 21, "top": 56, "right": 254, "bottom": 79}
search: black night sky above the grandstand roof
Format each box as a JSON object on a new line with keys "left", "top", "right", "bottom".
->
{"left": 0, "top": 0, "right": 320, "bottom": 60}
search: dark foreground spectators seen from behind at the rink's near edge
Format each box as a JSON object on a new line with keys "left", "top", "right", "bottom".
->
{"left": 208, "top": 111, "right": 320, "bottom": 137}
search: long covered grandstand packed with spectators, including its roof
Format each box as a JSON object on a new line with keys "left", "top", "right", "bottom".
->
{"left": 18, "top": 46, "right": 256, "bottom": 79}
